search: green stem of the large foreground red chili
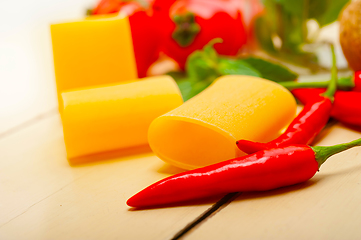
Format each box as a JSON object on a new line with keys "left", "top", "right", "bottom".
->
{"left": 311, "top": 138, "right": 361, "bottom": 167}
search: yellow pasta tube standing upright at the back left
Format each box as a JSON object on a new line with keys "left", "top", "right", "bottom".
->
{"left": 50, "top": 15, "right": 137, "bottom": 112}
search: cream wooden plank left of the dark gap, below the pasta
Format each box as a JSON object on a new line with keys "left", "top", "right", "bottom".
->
{"left": 0, "top": 115, "right": 215, "bottom": 240}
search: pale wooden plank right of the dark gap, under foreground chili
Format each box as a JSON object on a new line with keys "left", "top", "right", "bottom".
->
{"left": 186, "top": 124, "right": 361, "bottom": 240}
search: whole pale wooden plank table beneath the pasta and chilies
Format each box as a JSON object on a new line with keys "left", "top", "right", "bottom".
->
{"left": 0, "top": 0, "right": 361, "bottom": 240}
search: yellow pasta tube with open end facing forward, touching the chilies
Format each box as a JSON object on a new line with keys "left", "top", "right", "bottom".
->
{"left": 148, "top": 76, "right": 296, "bottom": 169}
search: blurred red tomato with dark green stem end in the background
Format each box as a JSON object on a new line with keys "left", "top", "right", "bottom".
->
{"left": 163, "top": 0, "right": 247, "bottom": 69}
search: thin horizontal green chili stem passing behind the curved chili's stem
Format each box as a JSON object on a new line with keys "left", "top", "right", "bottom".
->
{"left": 279, "top": 76, "right": 355, "bottom": 90}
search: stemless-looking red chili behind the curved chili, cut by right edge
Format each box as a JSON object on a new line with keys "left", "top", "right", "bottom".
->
{"left": 292, "top": 88, "right": 361, "bottom": 127}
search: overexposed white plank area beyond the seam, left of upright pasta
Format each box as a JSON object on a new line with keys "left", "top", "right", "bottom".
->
{"left": 0, "top": 0, "right": 97, "bottom": 134}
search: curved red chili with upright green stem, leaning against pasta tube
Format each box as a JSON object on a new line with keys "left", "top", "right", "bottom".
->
{"left": 236, "top": 44, "right": 337, "bottom": 154}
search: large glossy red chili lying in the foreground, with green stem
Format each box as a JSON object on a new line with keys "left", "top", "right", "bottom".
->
{"left": 127, "top": 139, "right": 361, "bottom": 207}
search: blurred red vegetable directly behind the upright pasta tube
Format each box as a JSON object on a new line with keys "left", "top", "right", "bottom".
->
{"left": 92, "top": 0, "right": 160, "bottom": 78}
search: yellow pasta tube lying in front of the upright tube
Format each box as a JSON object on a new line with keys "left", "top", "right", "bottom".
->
{"left": 62, "top": 76, "right": 183, "bottom": 158}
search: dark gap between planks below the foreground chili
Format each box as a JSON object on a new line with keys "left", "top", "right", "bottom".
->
{"left": 171, "top": 192, "right": 241, "bottom": 240}
